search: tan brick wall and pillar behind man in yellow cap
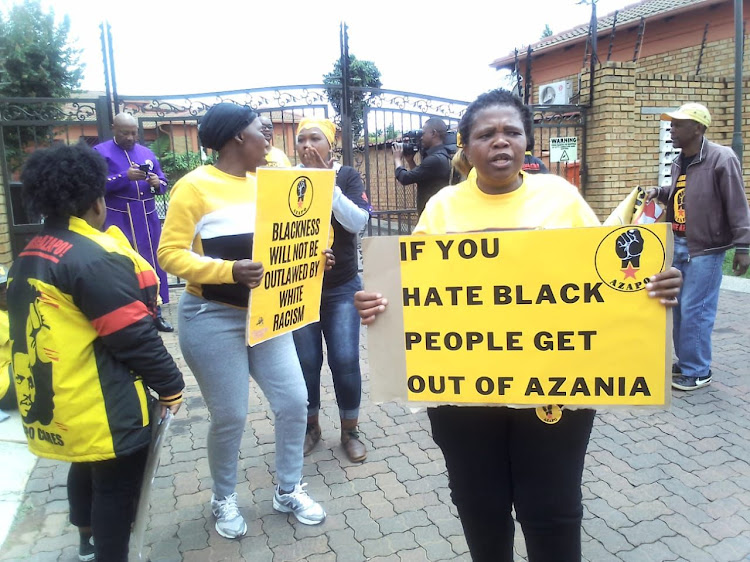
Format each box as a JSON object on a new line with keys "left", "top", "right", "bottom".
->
{"left": 581, "top": 62, "right": 750, "bottom": 219}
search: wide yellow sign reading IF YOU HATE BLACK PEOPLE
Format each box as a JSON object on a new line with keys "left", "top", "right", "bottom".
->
{"left": 363, "top": 224, "right": 672, "bottom": 406}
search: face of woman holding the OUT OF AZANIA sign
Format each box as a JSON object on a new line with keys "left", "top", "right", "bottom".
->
{"left": 464, "top": 105, "right": 526, "bottom": 194}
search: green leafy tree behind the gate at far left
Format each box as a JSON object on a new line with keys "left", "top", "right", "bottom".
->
{"left": 0, "top": 0, "right": 83, "bottom": 169}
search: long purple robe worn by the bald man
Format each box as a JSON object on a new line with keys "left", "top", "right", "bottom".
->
{"left": 94, "top": 140, "right": 169, "bottom": 303}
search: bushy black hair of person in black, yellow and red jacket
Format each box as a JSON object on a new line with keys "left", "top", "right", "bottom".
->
{"left": 21, "top": 144, "right": 107, "bottom": 218}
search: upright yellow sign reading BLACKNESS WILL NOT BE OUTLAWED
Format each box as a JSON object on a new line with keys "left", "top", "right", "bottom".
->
{"left": 247, "top": 168, "right": 336, "bottom": 346}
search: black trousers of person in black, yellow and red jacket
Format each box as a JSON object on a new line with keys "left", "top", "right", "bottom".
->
{"left": 68, "top": 447, "right": 148, "bottom": 562}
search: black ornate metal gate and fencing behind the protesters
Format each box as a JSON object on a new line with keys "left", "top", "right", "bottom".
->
{"left": 0, "top": 85, "right": 585, "bottom": 262}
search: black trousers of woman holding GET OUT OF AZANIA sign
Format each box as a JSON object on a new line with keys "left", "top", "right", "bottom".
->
{"left": 428, "top": 406, "right": 595, "bottom": 562}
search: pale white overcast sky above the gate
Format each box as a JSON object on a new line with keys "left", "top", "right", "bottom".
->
{"left": 0, "top": 0, "right": 633, "bottom": 101}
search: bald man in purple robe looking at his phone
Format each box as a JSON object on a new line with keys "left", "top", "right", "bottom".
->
{"left": 94, "top": 113, "right": 174, "bottom": 332}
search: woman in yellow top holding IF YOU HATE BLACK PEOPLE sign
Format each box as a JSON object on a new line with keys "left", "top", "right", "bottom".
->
{"left": 355, "top": 90, "right": 681, "bottom": 562}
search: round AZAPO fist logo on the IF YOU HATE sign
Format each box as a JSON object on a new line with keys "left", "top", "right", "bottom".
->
{"left": 594, "top": 225, "right": 666, "bottom": 293}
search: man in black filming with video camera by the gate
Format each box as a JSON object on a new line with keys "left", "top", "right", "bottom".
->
{"left": 393, "top": 117, "right": 453, "bottom": 214}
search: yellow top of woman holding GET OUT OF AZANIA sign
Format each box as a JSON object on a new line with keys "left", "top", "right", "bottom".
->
{"left": 414, "top": 170, "right": 599, "bottom": 234}
